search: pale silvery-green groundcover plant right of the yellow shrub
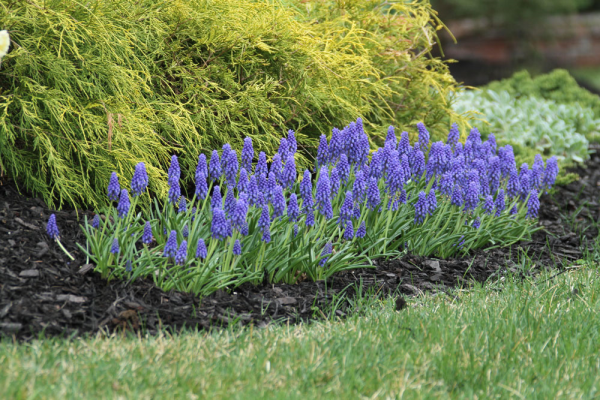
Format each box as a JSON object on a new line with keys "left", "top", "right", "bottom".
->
{"left": 454, "top": 90, "right": 600, "bottom": 162}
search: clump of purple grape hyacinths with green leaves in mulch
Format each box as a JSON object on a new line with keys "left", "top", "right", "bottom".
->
{"left": 48, "top": 118, "right": 558, "bottom": 294}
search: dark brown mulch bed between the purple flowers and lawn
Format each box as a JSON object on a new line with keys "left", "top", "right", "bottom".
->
{"left": 0, "top": 149, "right": 600, "bottom": 341}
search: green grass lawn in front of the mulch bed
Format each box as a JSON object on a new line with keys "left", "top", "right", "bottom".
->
{"left": 0, "top": 255, "right": 600, "bottom": 399}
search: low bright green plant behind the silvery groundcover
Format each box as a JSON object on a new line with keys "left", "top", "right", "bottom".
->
{"left": 484, "top": 69, "right": 600, "bottom": 117}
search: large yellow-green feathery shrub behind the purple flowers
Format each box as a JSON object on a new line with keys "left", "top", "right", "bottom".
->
{"left": 0, "top": 0, "right": 464, "bottom": 211}
